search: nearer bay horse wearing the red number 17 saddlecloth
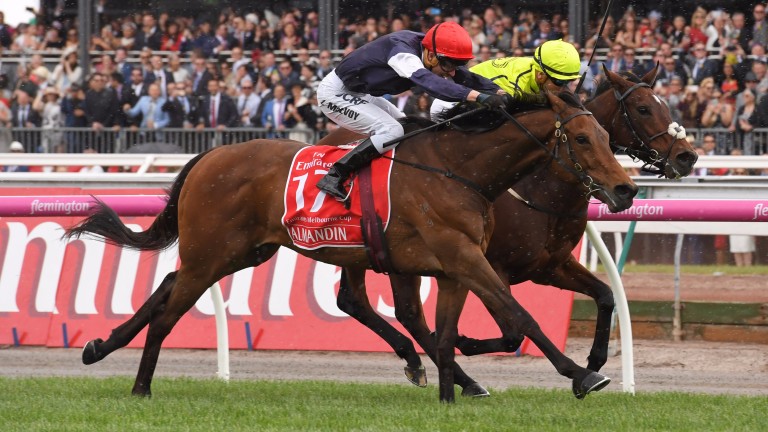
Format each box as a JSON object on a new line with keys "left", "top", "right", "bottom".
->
{"left": 65, "top": 90, "right": 637, "bottom": 402}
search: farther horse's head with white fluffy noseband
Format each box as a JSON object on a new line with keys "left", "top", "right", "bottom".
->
{"left": 587, "top": 68, "right": 698, "bottom": 178}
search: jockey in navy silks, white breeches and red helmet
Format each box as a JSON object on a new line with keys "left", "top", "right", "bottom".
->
{"left": 317, "top": 22, "right": 506, "bottom": 201}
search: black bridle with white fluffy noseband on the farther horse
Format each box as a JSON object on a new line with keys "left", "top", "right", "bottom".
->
{"left": 610, "top": 82, "right": 685, "bottom": 177}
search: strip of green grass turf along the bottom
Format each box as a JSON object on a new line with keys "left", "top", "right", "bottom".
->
{"left": 0, "top": 377, "right": 768, "bottom": 432}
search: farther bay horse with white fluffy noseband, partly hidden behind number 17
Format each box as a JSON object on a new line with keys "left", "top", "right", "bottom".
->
{"left": 317, "top": 69, "right": 697, "bottom": 398}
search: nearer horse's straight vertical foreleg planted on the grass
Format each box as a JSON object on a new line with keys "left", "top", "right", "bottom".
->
{"left": 435, "top": 277, "right": 468, "bottom": 403}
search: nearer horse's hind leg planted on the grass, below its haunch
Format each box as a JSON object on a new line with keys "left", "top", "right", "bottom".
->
{"left": 132, "top": 245, "right": 278, "bottom": 396}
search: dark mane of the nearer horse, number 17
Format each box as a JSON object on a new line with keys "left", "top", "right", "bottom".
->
{"left": 443, "top": 91, "right": 584, "bottom": 133}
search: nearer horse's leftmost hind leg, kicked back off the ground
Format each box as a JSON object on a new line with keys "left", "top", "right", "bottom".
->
{"left": 83, "top": 272, "right": 176, "bottom": 365}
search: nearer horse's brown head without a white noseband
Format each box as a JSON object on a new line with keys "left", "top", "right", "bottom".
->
{"left": 547, "top": 93, "right": 637, "bottom": 212}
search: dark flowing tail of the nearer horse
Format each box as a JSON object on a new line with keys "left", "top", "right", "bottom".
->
{"left": 64, "top": 150, "right": 210, "bottom": 250}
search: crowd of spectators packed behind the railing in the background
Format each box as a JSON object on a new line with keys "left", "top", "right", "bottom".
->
{"left": 0, "top": 3, "right": 768, "bottom": 154}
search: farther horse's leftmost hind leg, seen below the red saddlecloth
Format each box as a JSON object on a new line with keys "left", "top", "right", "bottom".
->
{"left": 336, "top": 268, "right": 427, "bottom": 387}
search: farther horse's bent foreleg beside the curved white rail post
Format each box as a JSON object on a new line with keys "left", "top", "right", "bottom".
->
{"left": 547, "top": 257, "right": 616, "bottom": 372}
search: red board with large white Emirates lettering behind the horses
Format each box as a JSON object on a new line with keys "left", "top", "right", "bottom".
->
{"left": 0, "top": 189, "right": 573, "bottom": 354}
